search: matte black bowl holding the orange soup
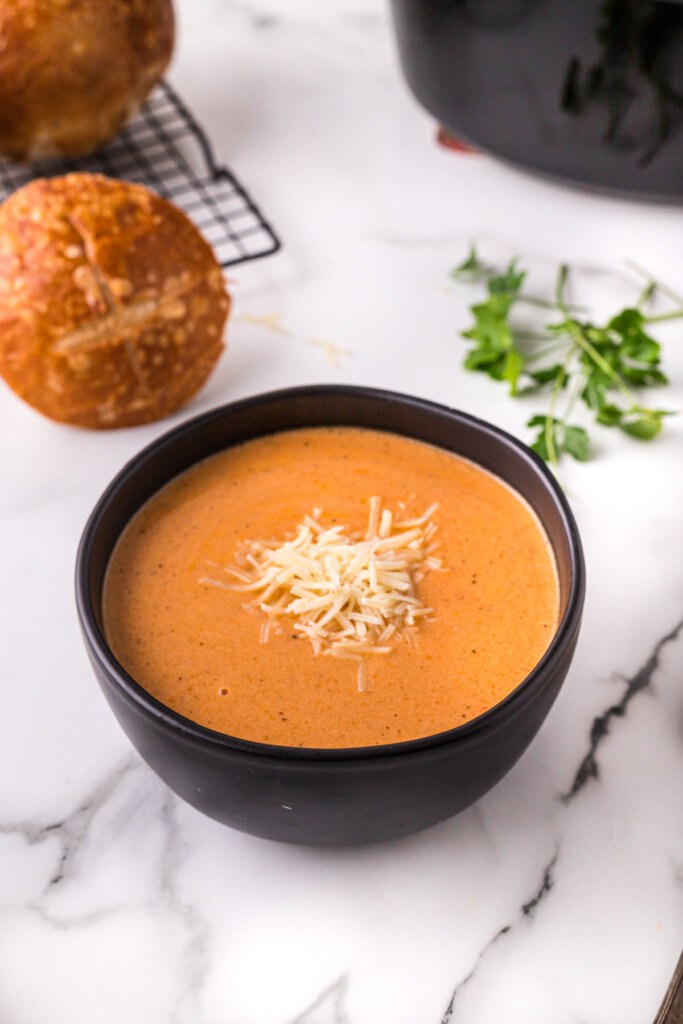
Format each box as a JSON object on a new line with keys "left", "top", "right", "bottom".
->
{"left": 76, "top": 386, "right": 585, "bottom": 846}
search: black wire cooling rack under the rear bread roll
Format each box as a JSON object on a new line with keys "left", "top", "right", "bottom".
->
{"left": 0, "top": 82, "right": 281, "bottom": 266}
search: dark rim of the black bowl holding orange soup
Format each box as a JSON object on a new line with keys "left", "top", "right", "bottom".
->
{"left": 75, "top": 384, "right": 586, "bottom": 762}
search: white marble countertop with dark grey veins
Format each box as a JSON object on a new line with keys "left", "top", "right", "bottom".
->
{"left": 0, "top": 0, "right": 683, "bottom": 1024}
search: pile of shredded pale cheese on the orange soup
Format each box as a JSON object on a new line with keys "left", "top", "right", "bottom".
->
{"left": 200, "top": 498, "right": 441, "bottom": 690}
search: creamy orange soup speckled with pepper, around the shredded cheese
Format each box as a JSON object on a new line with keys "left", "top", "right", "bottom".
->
{"left": 103, "top": 427, "right": 559, "bottom": 748}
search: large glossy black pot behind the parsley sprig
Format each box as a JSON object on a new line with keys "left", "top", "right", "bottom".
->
{"left": 391, "top": 0, "right": 683, "bottom": 201}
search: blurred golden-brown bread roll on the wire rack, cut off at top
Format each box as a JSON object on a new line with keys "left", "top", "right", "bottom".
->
{"left": 0, "top": 0, "right": 174, "bottom": 160}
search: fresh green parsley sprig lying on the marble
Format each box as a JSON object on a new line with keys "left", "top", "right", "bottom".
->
{"left": 452, "top": 246, "right": 683, "bottom": 465}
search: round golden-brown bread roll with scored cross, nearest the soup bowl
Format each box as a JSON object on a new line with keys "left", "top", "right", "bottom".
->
{"left": 0, "top": 174, "right": 229, "bottom": 429}
